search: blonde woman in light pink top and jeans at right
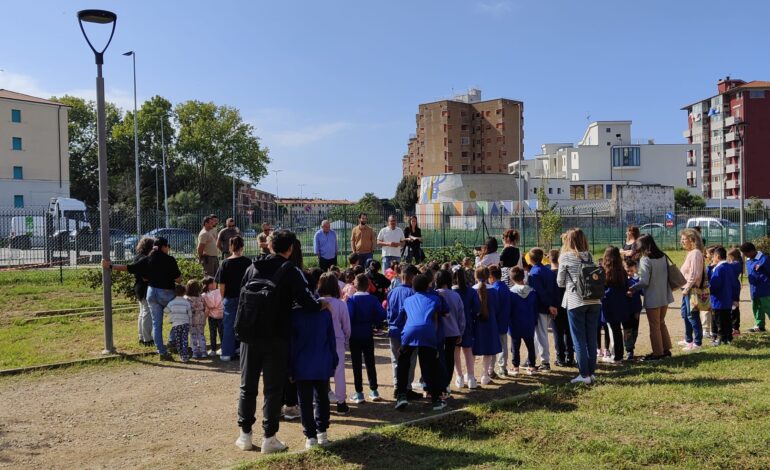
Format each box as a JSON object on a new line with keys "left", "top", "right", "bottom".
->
{"left": 679, "top": 228, "right": 705, "bottom": 351}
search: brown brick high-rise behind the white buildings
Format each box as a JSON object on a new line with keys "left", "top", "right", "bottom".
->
{"left": 402, "top": 89, "right": 524, "bottom": 179}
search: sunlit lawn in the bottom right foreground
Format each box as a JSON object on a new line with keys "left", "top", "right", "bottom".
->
{"left": 239, "top": 335, "right": 770, "bottom": 469}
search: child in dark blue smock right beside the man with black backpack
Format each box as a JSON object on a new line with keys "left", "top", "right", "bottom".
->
{"left": 289, "top": 298, "right": 340, "bottom": 449}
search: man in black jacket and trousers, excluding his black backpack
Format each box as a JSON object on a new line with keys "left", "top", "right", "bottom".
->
{"left": 235, "top": 230, "right": 327, "bottom": 454}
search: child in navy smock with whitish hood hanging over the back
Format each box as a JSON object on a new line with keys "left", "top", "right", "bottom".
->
{"left": 509, "top": 266, "right": 538, "bottom": 376}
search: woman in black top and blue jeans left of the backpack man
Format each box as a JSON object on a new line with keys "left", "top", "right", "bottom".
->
{"left": 214, "top": 235, "right": 251, "bottom": 361}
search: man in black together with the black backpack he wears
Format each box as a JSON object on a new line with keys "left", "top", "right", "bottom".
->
{"left": 235, "top": 230, "right": 328, "bottom": 454}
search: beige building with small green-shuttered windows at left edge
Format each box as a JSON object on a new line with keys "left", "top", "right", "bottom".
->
{"left": 0, "top": 89, "right": 70, "bottom": 208}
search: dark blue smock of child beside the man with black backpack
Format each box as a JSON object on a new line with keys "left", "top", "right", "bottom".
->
{"left": 289, "top": 308, "right": 339, "bottom": 381}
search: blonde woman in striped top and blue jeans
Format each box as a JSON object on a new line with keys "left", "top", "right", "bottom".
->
{"left": 556, "top": 228, "right": 602, "bottom": 384}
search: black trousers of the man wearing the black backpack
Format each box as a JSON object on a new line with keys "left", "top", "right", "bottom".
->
{"left": 238, "top": 338, "right": 289, "bottom": 437}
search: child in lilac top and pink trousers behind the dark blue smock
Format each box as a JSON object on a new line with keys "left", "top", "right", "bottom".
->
{"left": 318, "top": 272, "right": 350, "bottom": 414}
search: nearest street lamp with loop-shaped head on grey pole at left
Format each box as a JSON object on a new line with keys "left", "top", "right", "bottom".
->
{"left": 78, "top": 10, "right": 118, "bottom": 354}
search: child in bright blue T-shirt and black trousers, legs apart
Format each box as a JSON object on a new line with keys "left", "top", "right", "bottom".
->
{"left": 396, "top": 274, "right": 446, "bottom": 411}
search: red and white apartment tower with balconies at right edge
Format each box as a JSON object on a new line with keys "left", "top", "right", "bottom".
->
{"left": 682, "top": 77, "right": 770, "bottom": 199}
